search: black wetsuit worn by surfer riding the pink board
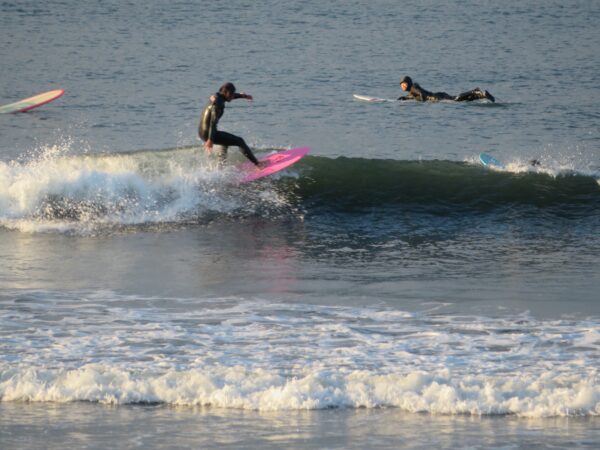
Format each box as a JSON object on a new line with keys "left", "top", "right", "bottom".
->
{"left": 198, "top": 92, "right": 258, "bottom": 165}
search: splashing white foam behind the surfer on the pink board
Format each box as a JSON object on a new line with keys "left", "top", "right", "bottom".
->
{"left": 0, "top": 143, "right": 285, "bottom": 233}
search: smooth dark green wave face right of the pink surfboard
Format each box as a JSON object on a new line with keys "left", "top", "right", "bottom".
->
{"left": 298, "top": 157, "right": 600, "bottom": 215}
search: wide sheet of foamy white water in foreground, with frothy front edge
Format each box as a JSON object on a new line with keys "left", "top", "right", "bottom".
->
{"left": 0, "top": 292, "right": 600, "bottom": 417}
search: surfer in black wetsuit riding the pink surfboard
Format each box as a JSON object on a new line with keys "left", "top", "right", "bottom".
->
{"left": 198, "top": 83, "right": 263, "bottom": 168}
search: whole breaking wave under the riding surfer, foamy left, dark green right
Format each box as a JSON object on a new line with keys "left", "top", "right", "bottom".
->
{"left": 0, "top": 147, "right": 600, "bottom": 233}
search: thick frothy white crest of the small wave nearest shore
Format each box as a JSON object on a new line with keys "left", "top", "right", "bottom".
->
{"left": 0, "top": 365, "right": 600, "bottom": 417}
